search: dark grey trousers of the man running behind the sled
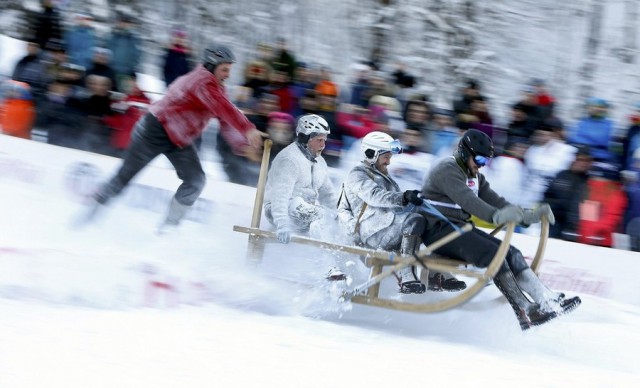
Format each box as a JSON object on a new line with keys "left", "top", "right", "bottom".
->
{"left": 95, "top": 113, "right": 206, "bottom": 206}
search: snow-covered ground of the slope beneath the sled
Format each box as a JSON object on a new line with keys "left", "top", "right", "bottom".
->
{"left": 0, "top": 142, "right": 640, "bottom": 388}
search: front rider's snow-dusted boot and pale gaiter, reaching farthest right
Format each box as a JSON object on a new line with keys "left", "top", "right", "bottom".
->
{"left": 516, "top": 268, "right": 582, "bottom": 314}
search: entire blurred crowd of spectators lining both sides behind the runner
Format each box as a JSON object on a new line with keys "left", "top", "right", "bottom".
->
{"left": 0, "top": 0, "right": 640, "bottom": 250}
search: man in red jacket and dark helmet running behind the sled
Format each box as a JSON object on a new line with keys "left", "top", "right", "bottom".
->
{"left": 82, "top": 46, "right": 262, "bottom": 232}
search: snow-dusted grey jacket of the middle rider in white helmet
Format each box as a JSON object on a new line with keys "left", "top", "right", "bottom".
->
{"left": 338, "top": 163, "right": 410, "bottom": 249}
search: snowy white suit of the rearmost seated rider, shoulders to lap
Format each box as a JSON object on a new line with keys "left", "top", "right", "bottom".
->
{"left": 264, "top": 141, "right": 338, "bottom": 232}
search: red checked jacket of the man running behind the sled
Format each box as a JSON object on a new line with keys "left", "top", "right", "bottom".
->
{"left": 149, "top": 65, "right": 254, "bottom": 149}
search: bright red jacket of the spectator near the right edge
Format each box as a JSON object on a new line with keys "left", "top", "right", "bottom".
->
{"left": 578, "top": 178, "right": 627, "bottom": 247}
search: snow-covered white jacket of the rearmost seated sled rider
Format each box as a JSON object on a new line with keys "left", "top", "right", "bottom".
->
{"left": 264, "top": 142, "right": 338, "bottom": 230}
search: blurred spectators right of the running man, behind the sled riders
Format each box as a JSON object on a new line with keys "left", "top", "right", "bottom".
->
{"left": 218, "top": 41, "right": 640, "bottom": 250}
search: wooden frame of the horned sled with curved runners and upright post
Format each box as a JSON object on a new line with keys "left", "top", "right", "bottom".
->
{"left": 233, "top": 139, "right": 549, "bottom": 313}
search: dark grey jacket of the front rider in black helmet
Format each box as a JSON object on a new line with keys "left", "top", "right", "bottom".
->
{"left": 422, "top": 157, "right": 509, "bottom": 224}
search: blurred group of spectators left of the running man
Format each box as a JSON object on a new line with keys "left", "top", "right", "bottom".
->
{"left": 1, "top": 0, "right": 193, "bottom": 156}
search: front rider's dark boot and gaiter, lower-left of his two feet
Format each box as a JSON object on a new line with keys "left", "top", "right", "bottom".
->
{"left": 493, "top": 270, "right": 558, "bottom": 331}
